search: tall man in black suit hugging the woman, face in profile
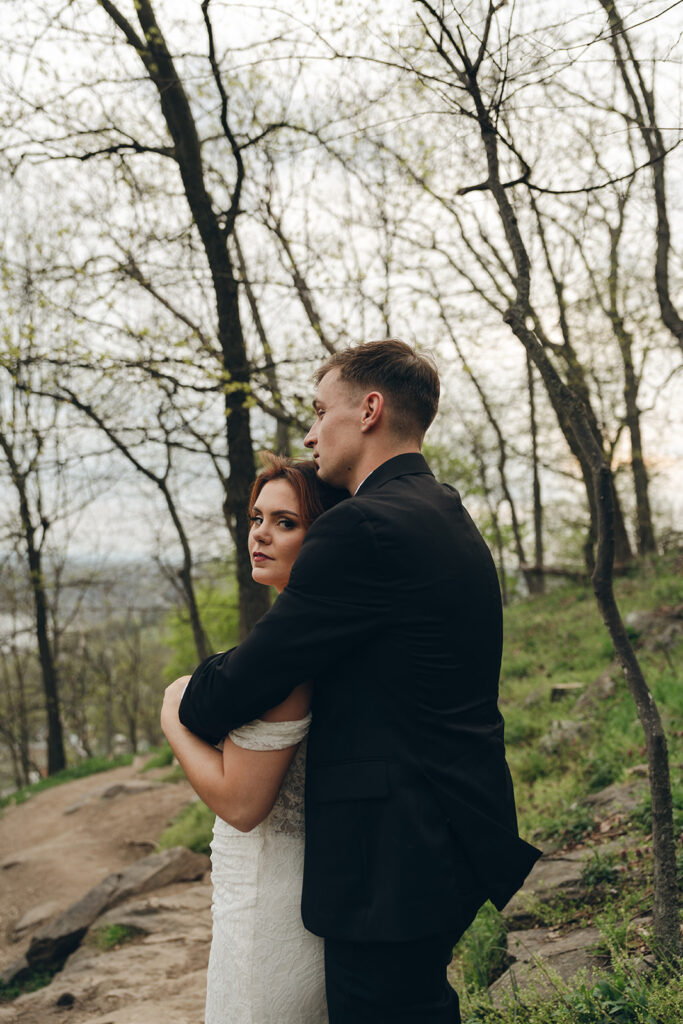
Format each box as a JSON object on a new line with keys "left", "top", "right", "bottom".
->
{"left": 180, "top": 340, "right": 539, "bottom": 1024}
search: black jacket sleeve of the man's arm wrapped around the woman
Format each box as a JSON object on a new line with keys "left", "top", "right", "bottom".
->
{"left": 179, "top": 499, "right": 387, "bottom": 742}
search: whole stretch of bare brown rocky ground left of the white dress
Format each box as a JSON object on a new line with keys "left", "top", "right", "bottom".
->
{"left": 0, "top": 764, "right": 211, "bottom": 1024}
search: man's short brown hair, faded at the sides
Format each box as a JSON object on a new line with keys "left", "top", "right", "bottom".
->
{"left": 313, "top": 338, "right": 440, "bottom": 438}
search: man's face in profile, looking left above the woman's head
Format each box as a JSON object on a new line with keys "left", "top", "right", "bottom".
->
{"left": 304, "top": 370, "right": 365, "bottom": 490}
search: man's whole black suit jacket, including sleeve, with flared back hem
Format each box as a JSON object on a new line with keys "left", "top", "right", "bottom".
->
{"left": 180, "top": 454, "right": 540, "bottom": 941}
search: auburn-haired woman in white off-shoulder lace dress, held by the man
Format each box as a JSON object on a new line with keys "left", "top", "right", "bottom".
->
{"left": 162, "top": 455, "right": 345, "bottom": 1024}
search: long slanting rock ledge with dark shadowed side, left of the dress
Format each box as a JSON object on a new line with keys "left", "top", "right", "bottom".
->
{"left": 11, "top": 846, "right": 210, "bottom": 967}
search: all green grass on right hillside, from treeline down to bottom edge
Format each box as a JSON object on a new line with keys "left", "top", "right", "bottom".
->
{"left": 453, "top": 558, "right": 683, "bottom": 1024}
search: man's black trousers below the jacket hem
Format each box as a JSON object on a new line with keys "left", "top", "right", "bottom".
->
{"left": 325, "top": 903, "right": 479, "bottom": 1024}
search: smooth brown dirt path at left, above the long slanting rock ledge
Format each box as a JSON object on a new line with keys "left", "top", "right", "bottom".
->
{"left": 0, "top": 763, "right": 197, "bottom": 969}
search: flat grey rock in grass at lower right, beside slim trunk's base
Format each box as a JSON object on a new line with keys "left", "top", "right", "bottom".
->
{"left": 488, "top": 928, "right": 608, "bottom": 1007}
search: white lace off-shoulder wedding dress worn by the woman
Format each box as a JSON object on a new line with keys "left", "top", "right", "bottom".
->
{"left": 205, "top": 715, "right": 328, "bottom": 1024}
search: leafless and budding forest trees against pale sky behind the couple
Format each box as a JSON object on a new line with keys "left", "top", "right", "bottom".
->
{"left": 0, "top": 0, "right": 683, "bottom": 1007}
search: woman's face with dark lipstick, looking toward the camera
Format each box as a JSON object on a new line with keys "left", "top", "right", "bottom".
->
{"left": 249, "top": 477, "right": 306, "bottom": 594}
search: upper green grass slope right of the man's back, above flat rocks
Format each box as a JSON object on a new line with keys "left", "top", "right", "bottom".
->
{"left": 501, "top": 560, "right": 683, "bottom": 848}
